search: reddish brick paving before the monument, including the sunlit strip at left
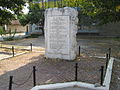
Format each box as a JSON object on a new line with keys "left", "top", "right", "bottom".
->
{"left": 0, "top": 52, "right": 104, "bottom": 90}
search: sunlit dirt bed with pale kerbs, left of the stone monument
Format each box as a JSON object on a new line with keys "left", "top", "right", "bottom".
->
{"left": 0, "top": 44, "right": 45, "bottom": 60}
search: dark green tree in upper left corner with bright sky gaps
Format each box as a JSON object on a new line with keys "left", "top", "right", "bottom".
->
{"left": 0, "top": 0, "right": 25, "bottom": 25}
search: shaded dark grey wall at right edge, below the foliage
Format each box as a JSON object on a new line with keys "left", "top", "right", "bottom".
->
{"left": 97, "top": 22, "right": 120, "bottom": 37}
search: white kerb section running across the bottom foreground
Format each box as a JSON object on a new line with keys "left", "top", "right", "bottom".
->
{"left": 30, "top": 82, "right": 105, "bottom": 90}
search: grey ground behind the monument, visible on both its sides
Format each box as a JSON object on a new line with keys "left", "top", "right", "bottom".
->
{"left": 3, "top": 36, "right": 120, "bottom": 58}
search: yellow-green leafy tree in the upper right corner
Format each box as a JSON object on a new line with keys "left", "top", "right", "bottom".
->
{"left": 81, "top": 0, "right": 120, "bottom": 24}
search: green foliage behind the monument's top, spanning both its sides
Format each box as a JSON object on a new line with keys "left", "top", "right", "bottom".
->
{"left": 20, "top": 0, "right": 120, "bottom": 25}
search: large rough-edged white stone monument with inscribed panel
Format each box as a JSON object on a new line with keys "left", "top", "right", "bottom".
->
{"left": 44, "top": 7, "right": 78, "bottom": 60}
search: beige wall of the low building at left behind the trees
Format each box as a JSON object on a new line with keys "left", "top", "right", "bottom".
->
{"left": 7, "top": 25, "right": 27, "bottom": 32}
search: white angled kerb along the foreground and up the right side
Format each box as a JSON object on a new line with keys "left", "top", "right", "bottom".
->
{"left": 30, "top": 58, "right": 114, "bottom": 90}
